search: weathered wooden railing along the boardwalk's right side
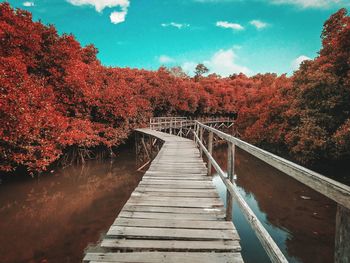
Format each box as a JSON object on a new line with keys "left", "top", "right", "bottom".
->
{"left": 194, "top": 121, "right": 350, "bottom": 263}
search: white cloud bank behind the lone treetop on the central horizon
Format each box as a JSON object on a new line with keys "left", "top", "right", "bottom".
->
{"left": 181, "top": 48, "right": 252, "bottom": 77}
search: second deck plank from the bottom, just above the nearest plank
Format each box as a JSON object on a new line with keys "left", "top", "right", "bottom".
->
{"left": 101, "top": 239, "right": 241, "bottom": 252}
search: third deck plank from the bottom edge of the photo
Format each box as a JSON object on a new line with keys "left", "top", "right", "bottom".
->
{"left": 107, "top": 226, "right": 239, "bottom": 240}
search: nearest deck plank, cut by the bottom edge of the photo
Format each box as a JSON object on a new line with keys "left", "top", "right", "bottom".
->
{"left": 83, "top": 252, "right": 243, "bottom": 263}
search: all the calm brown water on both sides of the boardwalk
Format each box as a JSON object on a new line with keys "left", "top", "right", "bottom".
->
{"left": 0, "top": 142, "right": 335, "bottom": 263}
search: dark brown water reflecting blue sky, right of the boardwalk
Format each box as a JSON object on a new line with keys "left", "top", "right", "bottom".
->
{"left": 214, "top": 147, "right": 336, "bottom": 263}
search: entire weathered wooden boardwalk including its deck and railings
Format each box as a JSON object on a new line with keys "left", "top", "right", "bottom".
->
{"left": 84, "top": 117, "right": 350, "bottom": 263}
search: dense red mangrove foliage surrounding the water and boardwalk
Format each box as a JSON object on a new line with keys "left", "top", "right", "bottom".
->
{"left": 0, "top": 3, "right": 350, "bottom": 175}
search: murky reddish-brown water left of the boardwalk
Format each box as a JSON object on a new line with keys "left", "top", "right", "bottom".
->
{"left": 0, "top": 146, "right": 141, "bottom": 263}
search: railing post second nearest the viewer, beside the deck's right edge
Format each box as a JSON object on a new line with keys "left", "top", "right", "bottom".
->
{"left": 226, "top": 142, "right": 235, "bottom": 221}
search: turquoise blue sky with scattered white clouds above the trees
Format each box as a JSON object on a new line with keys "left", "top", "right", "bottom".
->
{"left": 4, "top": 0, "right": 350, "bottom": 76}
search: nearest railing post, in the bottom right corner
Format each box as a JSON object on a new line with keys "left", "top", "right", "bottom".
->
{"left": 334, "top": 204, "right": 350, "bottom": 263}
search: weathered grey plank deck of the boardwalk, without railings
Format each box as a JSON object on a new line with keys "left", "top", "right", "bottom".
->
{"left": 84, "top": 129, "right": 243, "bottom": 263}
